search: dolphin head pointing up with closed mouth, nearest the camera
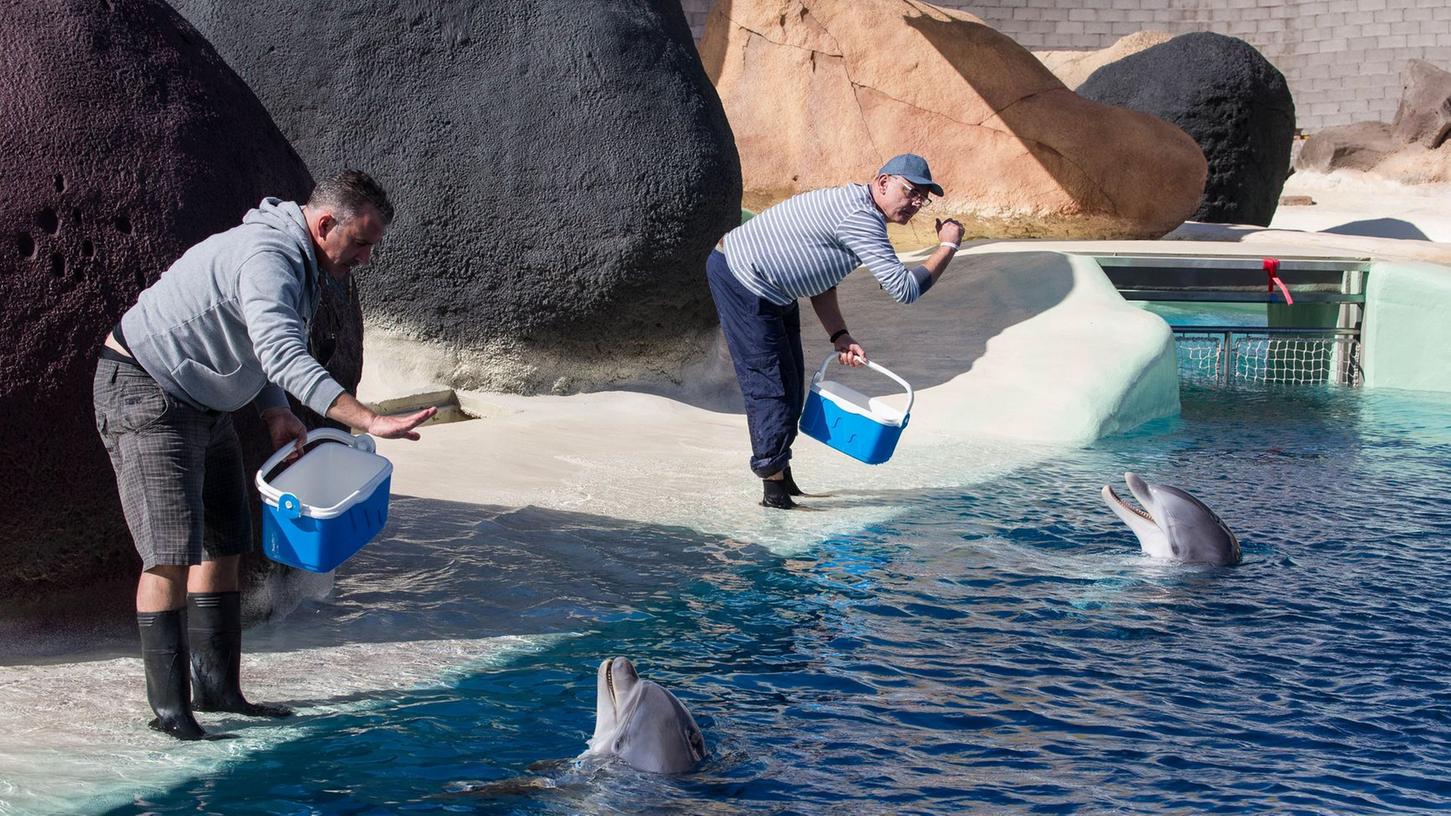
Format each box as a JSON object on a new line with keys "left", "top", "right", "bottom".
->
{"left": 588, "top": 658, "right": 705, "bottom": 774}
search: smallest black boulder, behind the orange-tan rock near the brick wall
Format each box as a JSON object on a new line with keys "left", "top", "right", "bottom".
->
{"left": 1078, "top": 32, "right": 1294, "bottom": 227}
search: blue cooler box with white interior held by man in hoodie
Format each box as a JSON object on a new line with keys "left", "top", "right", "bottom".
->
{"left": 257, "top": 428, "right": 393, "bottom": 572}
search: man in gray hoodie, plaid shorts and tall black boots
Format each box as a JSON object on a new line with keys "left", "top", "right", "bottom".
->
{"left": 94, "top": 170, "right": 435, "bottom": 739}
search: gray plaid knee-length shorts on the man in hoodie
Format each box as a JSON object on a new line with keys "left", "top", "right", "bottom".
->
{"left": 94, "top": 357, "right": 252, "bottom": 569}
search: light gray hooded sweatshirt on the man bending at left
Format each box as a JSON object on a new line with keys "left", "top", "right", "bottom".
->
{"left": 120, "top": 197, "right": 344, "bottom": 414}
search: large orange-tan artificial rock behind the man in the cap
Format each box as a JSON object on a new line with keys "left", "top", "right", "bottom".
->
{"left": 701, "top": 0, "right": 1206, "bottom": 238}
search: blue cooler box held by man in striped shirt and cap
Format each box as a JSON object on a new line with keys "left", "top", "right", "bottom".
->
{"left": 801, "top": 351, "right": 914, "bottom": 465}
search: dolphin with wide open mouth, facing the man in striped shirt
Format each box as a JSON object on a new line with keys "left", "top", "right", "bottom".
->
{"left": 1100, "top": 473, "right": 1239, "bottom": 566}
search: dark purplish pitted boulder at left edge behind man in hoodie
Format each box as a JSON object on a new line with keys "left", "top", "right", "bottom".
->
{"left": 0, "top": 0, "right": 320, "bottom": 632}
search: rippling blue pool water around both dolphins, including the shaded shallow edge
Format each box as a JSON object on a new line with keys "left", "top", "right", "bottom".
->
{"left": 99, "top": 389, "right": 1451, "bottom": 815}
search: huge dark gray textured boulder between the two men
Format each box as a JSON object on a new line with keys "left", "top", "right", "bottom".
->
{"left": 173, "top": 0, "right": 740, "bottom": 392}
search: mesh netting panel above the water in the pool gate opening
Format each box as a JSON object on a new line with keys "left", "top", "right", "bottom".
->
{"left": 1174, "top": 327, "right": 1361, "bottom": 386}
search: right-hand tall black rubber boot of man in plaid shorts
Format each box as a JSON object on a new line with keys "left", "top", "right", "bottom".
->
{"left": 186, "top": 592, "right": 292, "bottom": 717}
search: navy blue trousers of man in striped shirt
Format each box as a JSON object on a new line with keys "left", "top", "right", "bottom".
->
{"left": 705, "top": 250, "right": 805, "bottom": 478}
